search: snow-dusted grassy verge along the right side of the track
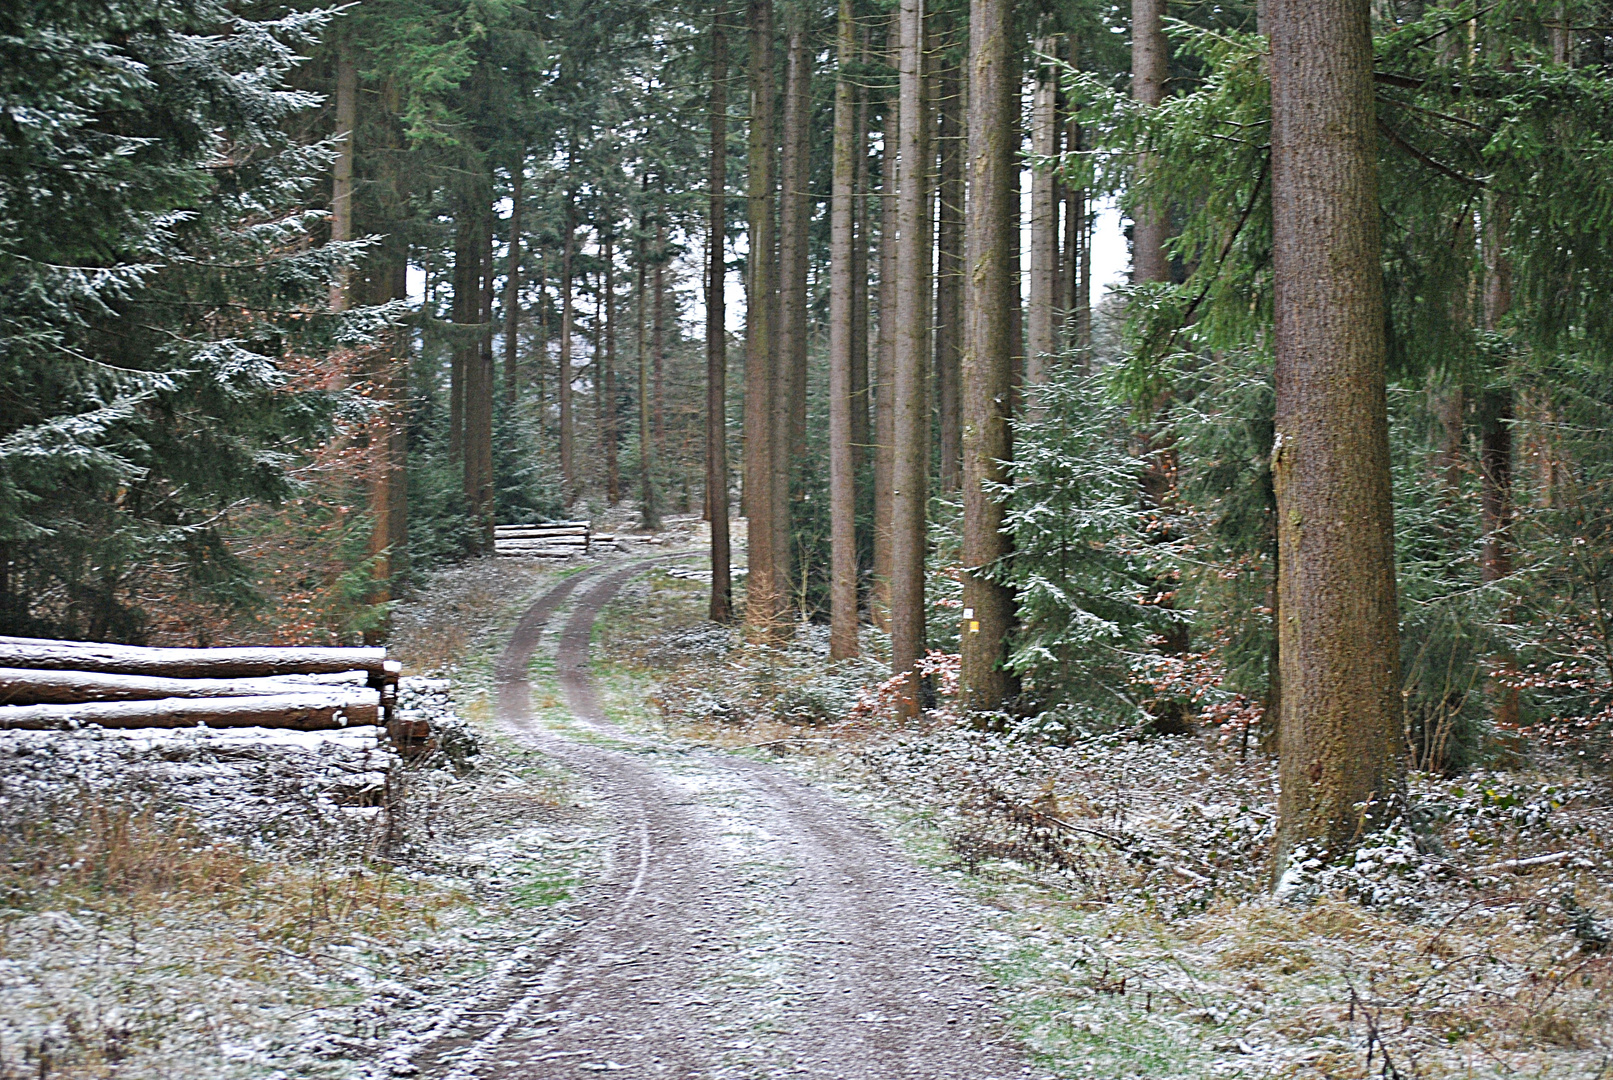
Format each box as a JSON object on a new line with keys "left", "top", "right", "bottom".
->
{"left": 597, "top": 574, "right": 1613, "bottom": 1080}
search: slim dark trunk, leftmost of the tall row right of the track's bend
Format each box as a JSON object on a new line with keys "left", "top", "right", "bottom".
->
{"left": 705, "top": 0, "right": 734, "bottom": 622}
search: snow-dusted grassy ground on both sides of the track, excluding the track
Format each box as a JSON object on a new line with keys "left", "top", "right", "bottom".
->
{"left": 12, "top": 559, "right": 1613, "bottom": 1080}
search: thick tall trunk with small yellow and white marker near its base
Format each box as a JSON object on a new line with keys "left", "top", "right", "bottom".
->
{"left": 960, "top": 0, "right": 1019, "bottom": 711}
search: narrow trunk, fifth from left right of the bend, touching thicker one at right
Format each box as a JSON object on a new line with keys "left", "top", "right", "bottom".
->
{"left": 868, "top": 16, "right": 902, "bottom": 632}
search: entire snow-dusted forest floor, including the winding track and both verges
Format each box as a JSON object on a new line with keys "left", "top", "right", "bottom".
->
{"left": 0, "top": 522, "right": 1613, "bottom": 1080}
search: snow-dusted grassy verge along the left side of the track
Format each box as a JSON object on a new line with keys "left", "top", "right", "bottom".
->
{"left": 0, "top": 559, "right": 602, "bottom": 1080}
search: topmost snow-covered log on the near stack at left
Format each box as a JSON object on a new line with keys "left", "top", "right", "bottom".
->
{"left": 0, "top": 637, "right": 398, "bottom": 682}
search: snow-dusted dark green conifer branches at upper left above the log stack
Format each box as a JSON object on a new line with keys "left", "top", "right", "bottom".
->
{"left": 0, "top": 0, "right": 387, "bottom": 640}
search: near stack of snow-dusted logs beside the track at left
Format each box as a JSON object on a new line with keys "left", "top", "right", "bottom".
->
{"left": 0, "top": 637, "right": 401, "bottom": 743}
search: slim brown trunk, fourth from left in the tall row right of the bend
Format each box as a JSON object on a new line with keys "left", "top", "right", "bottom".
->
{"left": 829, "top": 0, "right": 858, "bottom": 659}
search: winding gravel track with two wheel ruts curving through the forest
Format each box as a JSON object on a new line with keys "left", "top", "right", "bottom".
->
{"left": 421, "top": 561, "right": 1032, "bottom": 1080}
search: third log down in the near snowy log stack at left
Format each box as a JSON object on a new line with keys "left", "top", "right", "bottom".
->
{"left": 0, "top": 693, "right": 381, "bottom": 732}
